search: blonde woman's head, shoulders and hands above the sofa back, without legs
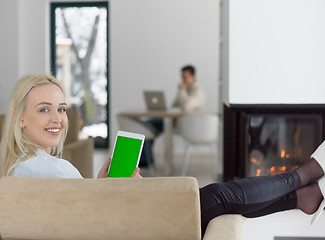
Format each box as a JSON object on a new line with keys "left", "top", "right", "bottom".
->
{"left": 0, "top": 74, "right": 140, "bottom": 178}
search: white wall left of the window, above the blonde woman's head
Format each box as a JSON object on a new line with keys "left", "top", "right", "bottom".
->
{"left": 0, "top": 0, "right": 49, "bottom": 114}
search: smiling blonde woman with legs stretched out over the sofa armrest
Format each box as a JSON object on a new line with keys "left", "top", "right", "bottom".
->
{"left": 0, "top": 74, "right": 325, "bottom": 238}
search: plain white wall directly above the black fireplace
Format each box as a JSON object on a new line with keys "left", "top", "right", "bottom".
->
{"left": 224, "top": 0, "right": 325, "bottom": 103}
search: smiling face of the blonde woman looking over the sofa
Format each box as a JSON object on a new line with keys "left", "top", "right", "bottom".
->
{"left": 22, "top": 84, "right": 68, "bottom": 153}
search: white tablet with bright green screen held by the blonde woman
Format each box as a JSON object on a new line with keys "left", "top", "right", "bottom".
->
{"left": 108, "top": 131, "right": 145, "bottom": 178}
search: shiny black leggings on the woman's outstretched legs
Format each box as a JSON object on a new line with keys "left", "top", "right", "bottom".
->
{"left": 200, "top": 171, "right": 300, "bottom": 236}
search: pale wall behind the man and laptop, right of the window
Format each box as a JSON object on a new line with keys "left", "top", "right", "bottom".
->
{"left": 110, "top": 0, "right": 220, "bottom": 148}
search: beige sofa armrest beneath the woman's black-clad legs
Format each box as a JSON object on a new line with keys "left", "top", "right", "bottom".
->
{"left": 203, "top": 215, "right": 246, "bottom": 240}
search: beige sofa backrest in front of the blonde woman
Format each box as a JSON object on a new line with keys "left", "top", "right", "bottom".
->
{"left": 0, "top": 177, "right": 201, "bottom": 240}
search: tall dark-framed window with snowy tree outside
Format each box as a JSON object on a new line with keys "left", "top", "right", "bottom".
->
{"left": 51, "top": 2, "right": 109, "bottom": 147}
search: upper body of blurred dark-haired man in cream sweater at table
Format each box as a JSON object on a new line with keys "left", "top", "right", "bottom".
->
{"left": 173, "top": 65, "right": 205, "bottom": 111}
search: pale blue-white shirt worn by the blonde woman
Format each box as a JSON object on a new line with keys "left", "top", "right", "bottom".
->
{"left": 13, "top": 149, "right": 83, "bottom": 178}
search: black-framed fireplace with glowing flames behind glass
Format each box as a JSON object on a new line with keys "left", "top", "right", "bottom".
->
{"left": 224, "top": 104, "right": 325, "bottom": 180}
